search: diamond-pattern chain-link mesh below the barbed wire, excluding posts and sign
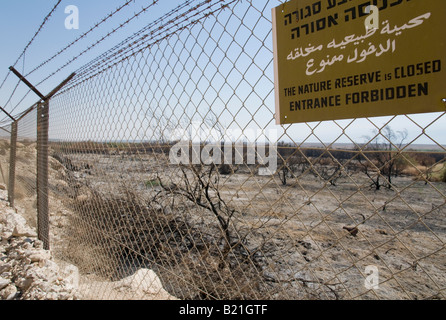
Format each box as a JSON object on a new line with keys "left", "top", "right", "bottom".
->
{"left": 2, "top": 0, "right": 446, "bottom": 299}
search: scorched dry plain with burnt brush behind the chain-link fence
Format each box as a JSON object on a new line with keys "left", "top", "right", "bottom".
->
{"left": 0, "top": 141, "right": 446, "bottom": 299}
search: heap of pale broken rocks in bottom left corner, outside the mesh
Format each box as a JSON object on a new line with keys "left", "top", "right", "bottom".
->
{"left": 0, "top": 185, "right": 81, "bottom": 300}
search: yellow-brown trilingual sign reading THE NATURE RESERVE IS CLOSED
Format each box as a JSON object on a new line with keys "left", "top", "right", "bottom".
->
{"left": 273, "top": 0, "right": 446, "bottom": 124}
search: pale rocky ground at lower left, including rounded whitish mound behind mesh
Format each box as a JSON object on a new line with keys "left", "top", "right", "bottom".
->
{"left": 0, "top": 184, "right": 176, "bottom": 300}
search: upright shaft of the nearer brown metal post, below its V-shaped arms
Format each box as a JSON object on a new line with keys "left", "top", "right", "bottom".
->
{"left": 37, "top": 100, "right": 50, "bottom": 250}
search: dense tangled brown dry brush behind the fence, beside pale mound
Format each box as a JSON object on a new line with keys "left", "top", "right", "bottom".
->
{"left": 66, "top": 188, "right": 268, "bottom": 299}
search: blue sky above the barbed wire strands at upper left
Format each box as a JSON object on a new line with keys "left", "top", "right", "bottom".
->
{"left": 0, "top": 0, "right": 186, "bottom": 119}
